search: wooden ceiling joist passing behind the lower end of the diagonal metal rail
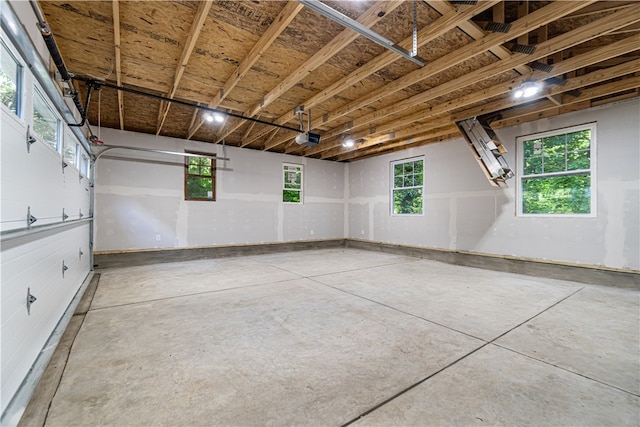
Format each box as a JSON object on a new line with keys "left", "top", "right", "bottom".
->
{"left": 256, "top": 0, "right": 501, "bottom": 149}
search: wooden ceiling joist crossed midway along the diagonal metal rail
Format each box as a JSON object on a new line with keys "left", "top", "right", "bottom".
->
{"left": 215, "top": 0, "right": 402, "bottom": 145}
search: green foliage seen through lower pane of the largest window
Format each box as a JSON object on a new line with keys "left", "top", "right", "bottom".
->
{"left": 522, "top": 173, "right": 591, "bottom": 214}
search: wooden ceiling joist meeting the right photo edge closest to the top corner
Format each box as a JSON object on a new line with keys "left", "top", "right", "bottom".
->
{"left": 312, "top": 2, "right": 640, "bottom": 150}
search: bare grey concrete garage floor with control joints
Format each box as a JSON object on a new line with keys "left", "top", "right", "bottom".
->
{"left": 23, "top": 249, "right": 640, "bottom": 426}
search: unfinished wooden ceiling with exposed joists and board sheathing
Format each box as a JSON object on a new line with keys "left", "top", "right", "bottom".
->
{"left": 39, "top": 0, "right": 640, "bottom": 161}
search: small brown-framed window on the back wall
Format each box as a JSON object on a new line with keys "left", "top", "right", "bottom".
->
{"left": 184, "top": 151, "right": 216, "bottom": 201}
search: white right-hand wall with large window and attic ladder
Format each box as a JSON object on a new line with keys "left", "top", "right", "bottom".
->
{"left": 347, "top": 98, "right": 640, "bottom": 270}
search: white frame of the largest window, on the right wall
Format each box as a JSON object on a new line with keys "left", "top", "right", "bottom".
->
{"left": 516, "top": 122, "right": 598, "bottom": 218}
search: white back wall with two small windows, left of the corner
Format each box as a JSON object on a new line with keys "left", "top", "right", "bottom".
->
{"left": 95, "top": 129, "right": 345, "bottom": 251}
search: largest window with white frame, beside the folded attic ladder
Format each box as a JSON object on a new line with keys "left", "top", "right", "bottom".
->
{"left": 517, "top": 124, "right": 596, "bottom": 216}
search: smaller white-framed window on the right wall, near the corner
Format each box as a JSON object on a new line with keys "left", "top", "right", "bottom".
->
{"left": 391, "top": 158, "right": 424, "bottom": 215}
